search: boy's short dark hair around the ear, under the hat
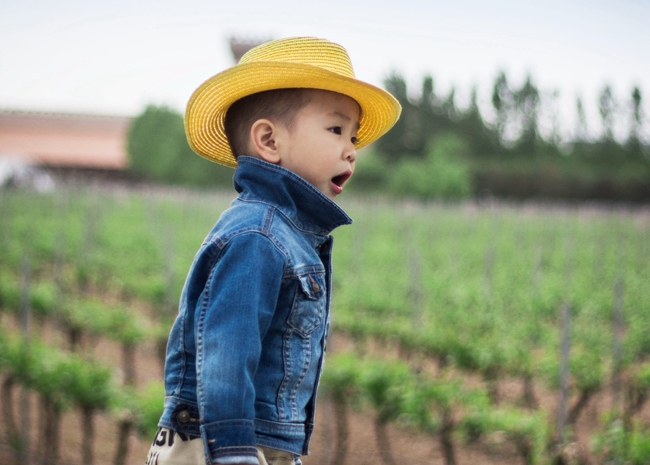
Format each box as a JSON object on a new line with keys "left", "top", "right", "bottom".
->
{"left": 224, "top": 88, "right": 312, "bottom": 158}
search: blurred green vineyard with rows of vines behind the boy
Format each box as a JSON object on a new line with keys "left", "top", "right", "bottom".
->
{"left": 0, "top": 186, "right": 650, "bottom": 465}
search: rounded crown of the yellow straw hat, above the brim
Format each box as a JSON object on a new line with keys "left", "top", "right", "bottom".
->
{"left": 239, "top": 37, "right": 354, "bottom": 78}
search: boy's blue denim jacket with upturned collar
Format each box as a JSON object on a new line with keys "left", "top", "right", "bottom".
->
{"left": 159, "top": 157, "right": 352, "bottom": 464}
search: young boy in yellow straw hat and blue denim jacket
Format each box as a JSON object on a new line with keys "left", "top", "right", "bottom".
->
{"left": 147, "top": 38, "right": 401, "bottom": 465}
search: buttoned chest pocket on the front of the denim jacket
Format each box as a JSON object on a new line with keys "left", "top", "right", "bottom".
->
{"left": 288, "top": 273, "right": 327, "bottom": 337}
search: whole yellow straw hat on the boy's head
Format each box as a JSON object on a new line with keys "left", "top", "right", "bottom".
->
{"left": 185, "top": 37, "right": 402, "bottom": 167}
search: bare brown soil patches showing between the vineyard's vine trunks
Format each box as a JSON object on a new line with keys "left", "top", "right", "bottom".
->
{"left": 0, "top": 318, "right": 628, "bottom": 465}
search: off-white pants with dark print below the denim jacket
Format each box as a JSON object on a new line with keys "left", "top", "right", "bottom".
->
{"left": 145, "top": 428, "right": 300, "bottom": 465}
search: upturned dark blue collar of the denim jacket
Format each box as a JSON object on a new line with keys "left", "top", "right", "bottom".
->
{"left": 234, "top": 156, "right": 352, "bottom": 235}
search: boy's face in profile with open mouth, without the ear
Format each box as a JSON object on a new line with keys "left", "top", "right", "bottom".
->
{"left": 278, "top": 90, "right": 361, "bottom": 200}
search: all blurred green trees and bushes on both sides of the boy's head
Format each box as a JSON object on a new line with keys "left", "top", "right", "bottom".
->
{"left": 128, "top": 72, "right": 650, "bottom": 202}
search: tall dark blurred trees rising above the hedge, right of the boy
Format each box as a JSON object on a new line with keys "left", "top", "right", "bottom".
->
{"left": 379, "top": 72, "right": 650, "bottom": 161}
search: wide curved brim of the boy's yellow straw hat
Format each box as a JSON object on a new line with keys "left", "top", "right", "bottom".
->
{"left": 185, "top": 62, "right": 401, "bottom": 167}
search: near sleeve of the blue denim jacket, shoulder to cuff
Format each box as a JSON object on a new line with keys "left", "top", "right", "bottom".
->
{"left": 195, "top": 232, "right": 285, "bottom": 464}
